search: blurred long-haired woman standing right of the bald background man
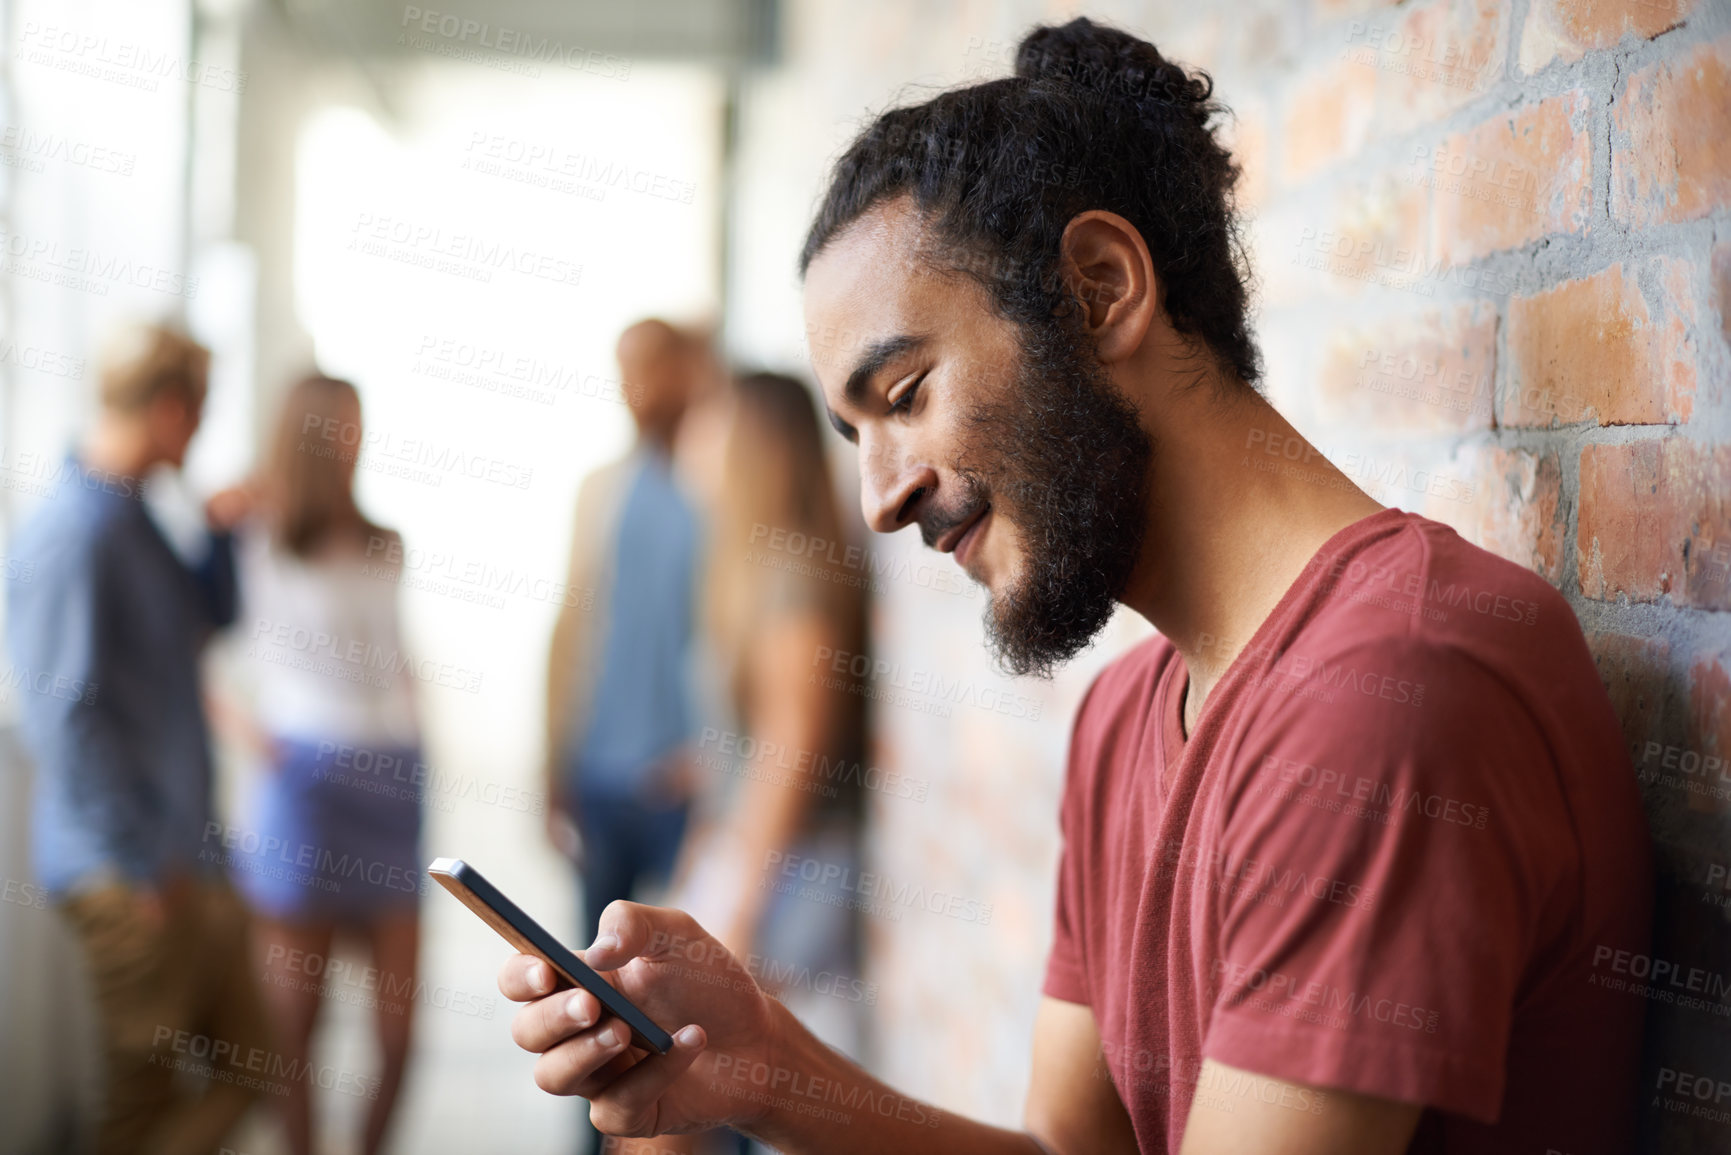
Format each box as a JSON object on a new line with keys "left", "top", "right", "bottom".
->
{"left": 661, "top": 372, "right": 866, "bottom": 1150}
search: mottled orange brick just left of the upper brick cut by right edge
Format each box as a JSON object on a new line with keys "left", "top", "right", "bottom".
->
{"left": 1411, "top": 90, "right": 1593, "bottom": 265}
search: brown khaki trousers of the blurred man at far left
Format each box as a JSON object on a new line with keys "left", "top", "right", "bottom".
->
{"left": 61, "top": 881, "right": 270, "bottom": 1155}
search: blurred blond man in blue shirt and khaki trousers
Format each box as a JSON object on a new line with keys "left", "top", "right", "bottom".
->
{"left": 7, "top": 326, "right": 268, "bottom": 1153}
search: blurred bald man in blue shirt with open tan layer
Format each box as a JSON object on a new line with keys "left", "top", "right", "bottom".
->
{"left": 545, "top": 319, "right": 711, "bottom": 1150}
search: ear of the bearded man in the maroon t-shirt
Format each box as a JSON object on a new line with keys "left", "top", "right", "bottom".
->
{"left": 1059, "top": 210, "right": 1160, "bottom": 364}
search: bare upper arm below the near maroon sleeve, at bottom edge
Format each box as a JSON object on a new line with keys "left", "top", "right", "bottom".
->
{"left": 1179, "top": 1058, "right": 1421, "bottom": 1155}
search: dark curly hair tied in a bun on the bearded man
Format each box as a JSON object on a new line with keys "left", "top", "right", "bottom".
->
{"left": 800, "top": 17, "right": 1262, "bottom": 386}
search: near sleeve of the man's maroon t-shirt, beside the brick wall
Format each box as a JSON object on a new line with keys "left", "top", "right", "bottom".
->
{"left": 1203, "top": 641, "right": 1568, "bottom": 1122}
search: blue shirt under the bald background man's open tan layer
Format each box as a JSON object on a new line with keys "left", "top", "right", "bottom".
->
{"left": 571, "top": 447, "right": 698, "bottom": 795}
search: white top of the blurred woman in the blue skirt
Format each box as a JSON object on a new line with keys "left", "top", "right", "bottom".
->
{"left": 235, "top": 532, "right": 419, "bottom": 745}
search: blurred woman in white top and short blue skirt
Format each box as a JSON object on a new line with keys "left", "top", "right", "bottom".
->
{"left": 223, "top": 376, "right": 428, "bottom": 1155}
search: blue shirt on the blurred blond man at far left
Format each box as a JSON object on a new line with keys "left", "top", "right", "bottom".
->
{"left": 7, "top": 459, "right": 235, "bottom": 894}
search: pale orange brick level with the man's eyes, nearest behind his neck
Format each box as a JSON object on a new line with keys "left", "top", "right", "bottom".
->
{"left": 1316, "top": 301, "right": 1497, "bottom": 433}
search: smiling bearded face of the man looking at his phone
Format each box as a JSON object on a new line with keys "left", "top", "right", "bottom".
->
{"left": 805, "top": 203, "right": 1153, "bottom": 674}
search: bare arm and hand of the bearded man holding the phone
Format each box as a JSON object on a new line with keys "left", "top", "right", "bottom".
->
{"left": 499, "top": 902, "right": 1136, "bottom": 1155}
